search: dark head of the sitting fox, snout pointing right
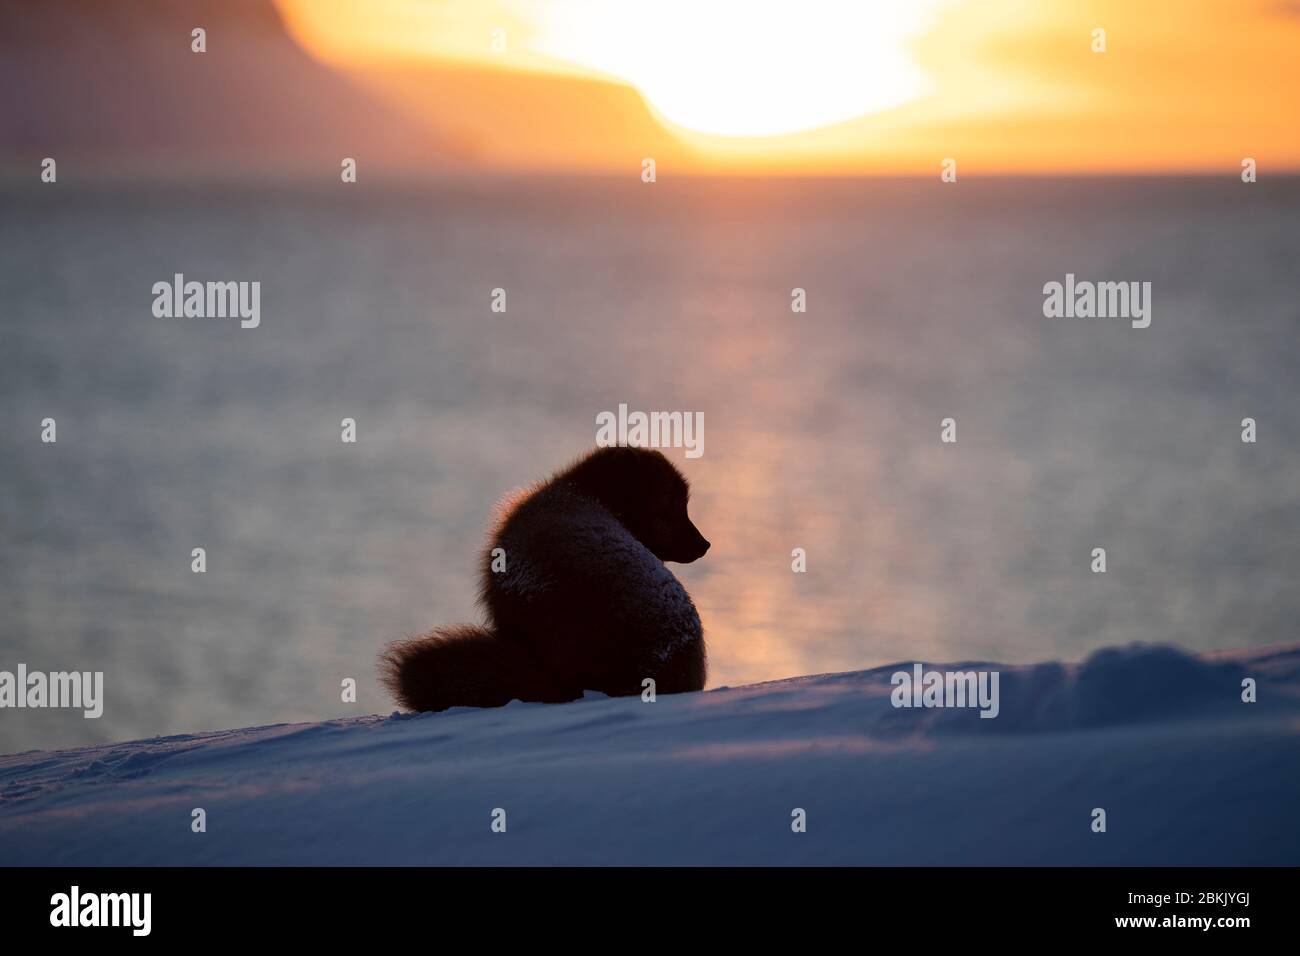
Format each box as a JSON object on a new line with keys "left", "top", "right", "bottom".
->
{"left": 559, "top": 445, "right": 709, "bottom": 564}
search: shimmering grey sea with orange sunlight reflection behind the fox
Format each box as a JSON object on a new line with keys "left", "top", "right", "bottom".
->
{"left": 0, "top": 176, "right": 1300, "bottom": 752}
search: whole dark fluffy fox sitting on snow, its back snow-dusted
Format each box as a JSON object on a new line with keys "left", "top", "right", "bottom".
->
{"left": 380, "top": 446, "right": 709, "bottom": 710}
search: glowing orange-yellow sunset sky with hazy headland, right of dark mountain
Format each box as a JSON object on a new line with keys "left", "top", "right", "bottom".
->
{"left": 278, "top": 0, "right": 1300, "bottom": 176}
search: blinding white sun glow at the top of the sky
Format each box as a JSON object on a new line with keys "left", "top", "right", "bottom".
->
{"left": 532, "top": 0, "right": 940, "bottom": 137}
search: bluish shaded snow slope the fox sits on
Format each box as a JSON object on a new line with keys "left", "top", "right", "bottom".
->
{"left": 0, "top": 645, "right": 1300, "bottom": 865}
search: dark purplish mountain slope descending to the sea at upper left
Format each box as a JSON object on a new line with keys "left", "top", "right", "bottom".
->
{"left": 0, "top": 0, "right": 463, "bottom": 179}
